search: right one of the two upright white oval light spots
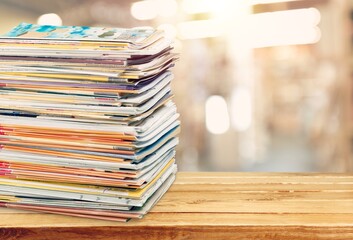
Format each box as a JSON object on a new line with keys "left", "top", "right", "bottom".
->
{"left": 231, "top": 87, "right": 252, "bottom": 131}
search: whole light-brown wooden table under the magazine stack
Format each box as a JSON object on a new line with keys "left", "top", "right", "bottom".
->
{"left": 0, "top": 173, "right": 353, "bottom": 240}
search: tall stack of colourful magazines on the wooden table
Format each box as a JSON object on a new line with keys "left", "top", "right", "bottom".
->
{"left": 0, "top": 23, "right": 180, "bottom": 221}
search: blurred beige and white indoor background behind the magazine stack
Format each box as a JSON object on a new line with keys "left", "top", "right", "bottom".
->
{"left": 0, "top": 0, "right": 353, "bottom": 172}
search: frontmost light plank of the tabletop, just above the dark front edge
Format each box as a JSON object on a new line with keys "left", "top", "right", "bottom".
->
{"left": 0, "top": 212, "right": 353, "bottom": 227}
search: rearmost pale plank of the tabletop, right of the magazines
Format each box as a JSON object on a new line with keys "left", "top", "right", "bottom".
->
{"left": 172, "top": 173, "right": 353, "bottom": 192}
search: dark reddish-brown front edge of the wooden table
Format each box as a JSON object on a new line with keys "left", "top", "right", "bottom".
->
{"left": 0, "top": 226, "right": 353, "bottom": 240}
